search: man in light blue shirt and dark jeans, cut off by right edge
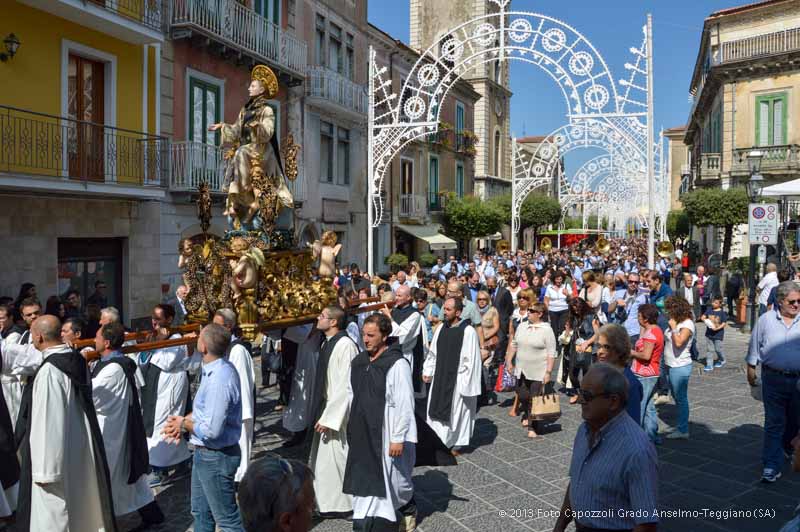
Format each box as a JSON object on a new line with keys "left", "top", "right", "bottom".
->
{"left": 747, "top": 281, "right": 800, "bottom": 482}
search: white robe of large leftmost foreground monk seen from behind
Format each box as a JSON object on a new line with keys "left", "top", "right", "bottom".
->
{"left": 30, "top": 345, "right": 105, "bottom": 532}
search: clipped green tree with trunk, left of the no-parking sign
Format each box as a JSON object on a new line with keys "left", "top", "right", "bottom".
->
{"left": 681, "top": 187, "right": 750, "bottom": 262}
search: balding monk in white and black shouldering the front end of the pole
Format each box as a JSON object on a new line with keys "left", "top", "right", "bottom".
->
{"left": 381, "top": 285, "right": 427, "bottom": 397}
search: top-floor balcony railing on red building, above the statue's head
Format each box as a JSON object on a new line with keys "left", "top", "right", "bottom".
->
{"left": 170, "top": 0, "right": 307, "bottom": 77}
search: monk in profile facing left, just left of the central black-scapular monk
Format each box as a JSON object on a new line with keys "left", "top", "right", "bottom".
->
{"left": 309, "top": 306, "right": 358, "bottom": 517}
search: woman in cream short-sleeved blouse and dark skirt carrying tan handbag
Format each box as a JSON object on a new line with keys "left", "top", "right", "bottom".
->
{"left": 506, "top": 302, "right": 556, "bottom": 438}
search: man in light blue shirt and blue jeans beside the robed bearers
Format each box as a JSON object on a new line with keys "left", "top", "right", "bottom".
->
{"left": 162, "top": 323, "right": 242, "bottom": 532}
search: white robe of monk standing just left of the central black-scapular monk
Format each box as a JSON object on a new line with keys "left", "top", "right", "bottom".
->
{"left": 309, "top": 337, "right": 358, "bottom": 512}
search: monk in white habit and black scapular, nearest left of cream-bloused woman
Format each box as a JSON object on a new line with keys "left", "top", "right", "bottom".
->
{"left": 422, "top": 298, "right": 481, "bottom": 454}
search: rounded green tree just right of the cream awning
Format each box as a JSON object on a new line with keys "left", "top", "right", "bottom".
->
{"left": 444, "top": 194, "right": 503, "bottom": 247}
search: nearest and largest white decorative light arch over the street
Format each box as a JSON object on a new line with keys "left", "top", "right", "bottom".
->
{"left": 367, "top": 0, "right": 654, "bottom": 273}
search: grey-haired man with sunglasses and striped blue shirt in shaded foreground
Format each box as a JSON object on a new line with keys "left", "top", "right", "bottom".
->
{"left": 553, "top": 362, "right": 659, "bottom": 532}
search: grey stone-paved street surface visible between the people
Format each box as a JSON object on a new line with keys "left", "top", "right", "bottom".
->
{"left": 112, "top": 324, "right": 800, "bottom": 532}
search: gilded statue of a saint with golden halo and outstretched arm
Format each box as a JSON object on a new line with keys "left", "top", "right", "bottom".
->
{"left": 208, "top": 65, "right": 293, "bottom": 232}
